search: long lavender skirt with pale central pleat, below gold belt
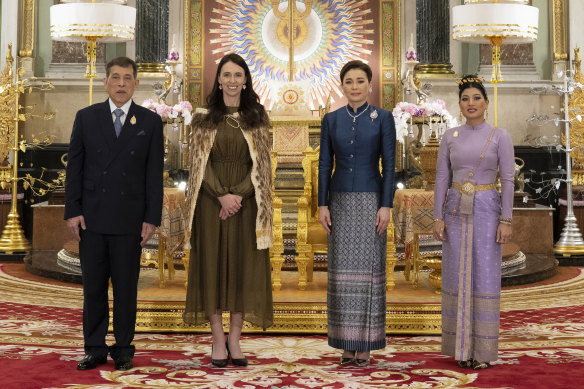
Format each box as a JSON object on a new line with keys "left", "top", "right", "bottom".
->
{"left": 442, "top": 188, "right": 502, "bottom": 362}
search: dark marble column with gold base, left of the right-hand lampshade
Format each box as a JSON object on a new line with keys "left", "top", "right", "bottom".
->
{"left": 416, "top": 0, "right": 454, "bottom": 77}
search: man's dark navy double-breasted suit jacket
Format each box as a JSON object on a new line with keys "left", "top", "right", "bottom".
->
{"left": 65, "top": 100, "right": 164, "bottom": 235}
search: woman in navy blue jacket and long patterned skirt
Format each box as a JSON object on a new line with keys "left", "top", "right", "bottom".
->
{"left": 318, "top": 61, "right": 395, "bottom": 366}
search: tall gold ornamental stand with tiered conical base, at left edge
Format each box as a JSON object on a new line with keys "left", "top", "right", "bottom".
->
{"left": 0, "top": 45, "right": 31, "bottom": 254}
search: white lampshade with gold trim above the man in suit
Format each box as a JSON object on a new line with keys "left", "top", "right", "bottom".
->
{"left": 50, "top": 3, "right": 136, "bottom": 42}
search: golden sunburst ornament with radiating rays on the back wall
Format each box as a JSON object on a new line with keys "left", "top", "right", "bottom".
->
{"left": 209, "top": 0, "right": 374, "bottom": 108}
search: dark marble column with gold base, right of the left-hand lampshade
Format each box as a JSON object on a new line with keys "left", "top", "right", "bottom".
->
{"left": 135, "top": 0, "right": 169, "bottom": 73}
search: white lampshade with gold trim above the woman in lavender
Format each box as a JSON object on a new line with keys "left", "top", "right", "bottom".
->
{"left": 452, "top": 0, "right": 539, "bottom": 43}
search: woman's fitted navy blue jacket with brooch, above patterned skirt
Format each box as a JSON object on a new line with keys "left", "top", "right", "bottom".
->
{"left": 318, "top": 105, "right": 395, "bottom": 207}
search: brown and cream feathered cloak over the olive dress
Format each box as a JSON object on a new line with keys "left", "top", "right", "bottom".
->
{"left": 184, "top": 108, "right": 273, "bottom": 250}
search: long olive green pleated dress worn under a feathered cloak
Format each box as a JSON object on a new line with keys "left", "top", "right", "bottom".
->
{"left": 183, "top": 107, "right": 273, "bottom": 329}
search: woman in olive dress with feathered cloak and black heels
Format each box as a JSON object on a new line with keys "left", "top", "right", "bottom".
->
{"left": 183, "top": 54, "right": 273, "bottom": 367}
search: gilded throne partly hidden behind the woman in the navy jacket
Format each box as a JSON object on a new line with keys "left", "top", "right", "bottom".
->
{"left": 296, "top": 146, "right": 396, "bottom": 290}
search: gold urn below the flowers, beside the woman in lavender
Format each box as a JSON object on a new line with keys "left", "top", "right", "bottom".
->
{"left": 408, "top": 116, "right": 442, "bottom": 191}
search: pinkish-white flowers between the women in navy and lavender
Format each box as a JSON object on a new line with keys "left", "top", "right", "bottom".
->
{"left": 393, "top": 99, "right": 458, "bottom": 142}
